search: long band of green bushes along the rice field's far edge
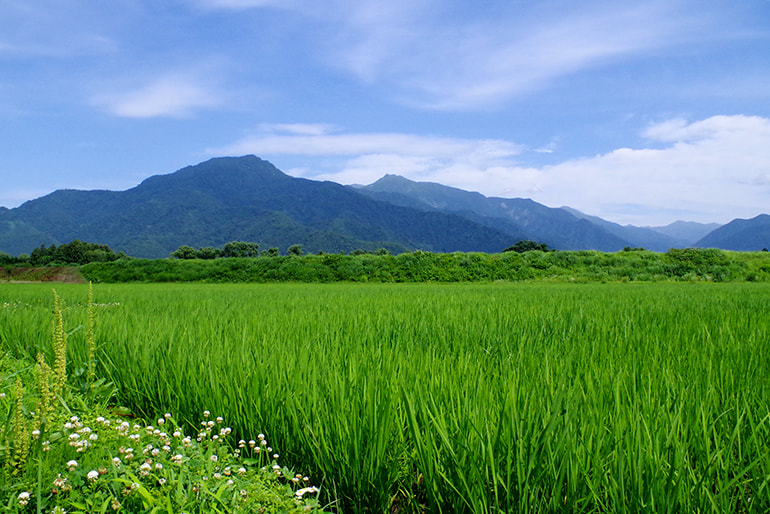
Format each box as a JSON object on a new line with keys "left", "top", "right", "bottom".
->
{"left": 81, "top": 248, "right": 770, "bottom": 282}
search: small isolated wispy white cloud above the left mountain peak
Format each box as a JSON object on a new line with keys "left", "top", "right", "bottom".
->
{"left": 93, "top": 73, "right": 224, "bottom": 118}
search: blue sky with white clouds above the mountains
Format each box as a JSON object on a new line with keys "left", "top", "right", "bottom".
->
{"left": 0, "top": 0, "right": 770, "bottom": 225}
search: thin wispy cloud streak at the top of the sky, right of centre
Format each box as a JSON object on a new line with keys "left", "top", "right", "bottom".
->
{"left": 316, "top": 0, "right": 708, "bottom": 110}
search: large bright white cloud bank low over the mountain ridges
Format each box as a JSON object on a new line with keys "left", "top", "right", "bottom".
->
{"left": 210, "top": 116, "right": 770, "bottom": 225}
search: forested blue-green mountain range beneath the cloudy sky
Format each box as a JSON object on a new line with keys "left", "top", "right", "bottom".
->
{"left": 0, "top": 155, "right": 770, "bottom": 258}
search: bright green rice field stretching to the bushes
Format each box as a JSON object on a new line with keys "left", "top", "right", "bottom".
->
{"left": 0, "top": 282, "right": 770, "bottom": 513}
